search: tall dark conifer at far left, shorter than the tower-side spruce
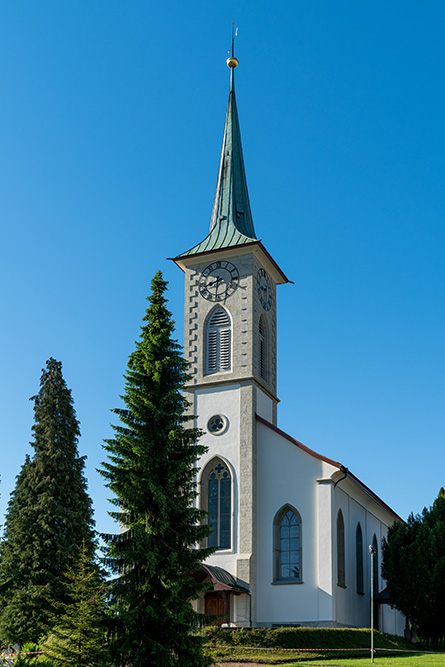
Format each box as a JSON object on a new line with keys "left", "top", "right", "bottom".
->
{"left": 0, "top": 358, "right": 95, "bottom": 644}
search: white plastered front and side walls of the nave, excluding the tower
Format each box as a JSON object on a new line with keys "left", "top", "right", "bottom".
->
{"left": 257, "top": 423, "right": 404, "bottom": 634}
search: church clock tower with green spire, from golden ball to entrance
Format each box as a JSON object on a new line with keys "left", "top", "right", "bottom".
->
{"left": 170, "top": 55, "right": 288, "bottom": 623}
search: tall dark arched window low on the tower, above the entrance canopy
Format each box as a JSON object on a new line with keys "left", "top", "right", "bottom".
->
{"left": 203, "top": 458, "right": 232, "bottom": 549}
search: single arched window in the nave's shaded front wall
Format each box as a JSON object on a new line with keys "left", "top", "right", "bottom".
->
{"left": 274, "top": 505, "right": 302, "bottom": 583}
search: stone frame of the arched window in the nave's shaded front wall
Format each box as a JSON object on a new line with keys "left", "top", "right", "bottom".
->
{"left": 273, "top": 505, "right": 303, "bottom": 584}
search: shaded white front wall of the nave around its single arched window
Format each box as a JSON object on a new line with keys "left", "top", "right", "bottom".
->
{"left": 253, "top": 423, "right": 336, "bottom": 625}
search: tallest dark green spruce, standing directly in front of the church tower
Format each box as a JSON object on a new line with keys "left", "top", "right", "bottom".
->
{"left": 102, "top": 272, "right": 211, "bottom": 667}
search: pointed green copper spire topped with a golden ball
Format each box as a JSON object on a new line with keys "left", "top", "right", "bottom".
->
{"left": 175, "top": 57, "right": 257, "bottom": 257}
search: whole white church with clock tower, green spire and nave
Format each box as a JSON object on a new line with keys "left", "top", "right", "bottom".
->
{"left": 174, "top": 52, "right": 404, "bottom": 634}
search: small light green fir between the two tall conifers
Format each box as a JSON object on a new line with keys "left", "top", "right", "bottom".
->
{"left": 40, "top": 544, "right": 108, "bottom": 667}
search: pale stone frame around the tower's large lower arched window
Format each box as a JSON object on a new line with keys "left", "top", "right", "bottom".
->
{"left": 200, "top": 456, "right": 234, "bottom": 551}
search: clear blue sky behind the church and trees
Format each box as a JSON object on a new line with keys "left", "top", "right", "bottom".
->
{"left": 0, "top": 0, "right": 445, "bottom": 531}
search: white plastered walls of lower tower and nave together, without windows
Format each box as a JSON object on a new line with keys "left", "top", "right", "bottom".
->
{"left": 189, "top": 374, "right": 405, "bottom": 634}
